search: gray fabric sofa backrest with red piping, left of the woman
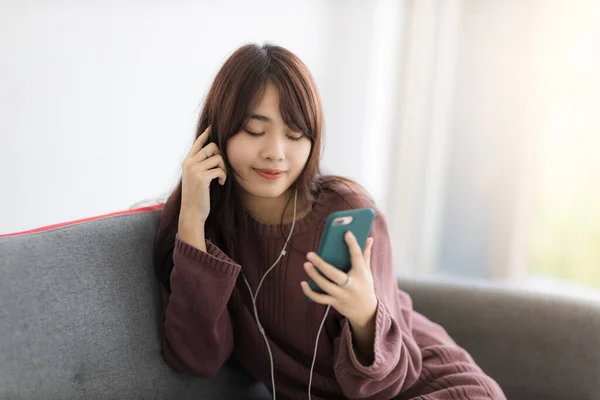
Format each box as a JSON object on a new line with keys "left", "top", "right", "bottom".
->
{"left": 0, "top": 207, "right": 270, "bottom": 400}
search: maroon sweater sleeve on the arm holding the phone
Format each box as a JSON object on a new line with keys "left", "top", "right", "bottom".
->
{"left": 334, "top": 213, "right": 422, "bottom": 400}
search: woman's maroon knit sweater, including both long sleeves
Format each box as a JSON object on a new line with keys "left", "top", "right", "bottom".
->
{"left": 161, "top": 184, "right": 506, "bottom": 400}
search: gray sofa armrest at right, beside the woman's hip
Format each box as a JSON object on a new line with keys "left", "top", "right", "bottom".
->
{"left": 398, "top": 277, "right": 600, "bottom": 400}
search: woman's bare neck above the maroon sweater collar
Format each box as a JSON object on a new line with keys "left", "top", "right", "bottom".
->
{"left": 242, "top": 190, "right": 310, "bottom": 225}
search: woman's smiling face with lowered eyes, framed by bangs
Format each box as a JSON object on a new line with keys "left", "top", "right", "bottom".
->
{"left": 226, "top": 82, "right": 311, "bottom": 202}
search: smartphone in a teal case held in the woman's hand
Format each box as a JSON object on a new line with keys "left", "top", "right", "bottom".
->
{"left": 305, "top": 208, "right": 375, "bottom": 301}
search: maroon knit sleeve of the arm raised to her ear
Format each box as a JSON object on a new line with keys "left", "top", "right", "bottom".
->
{"left": 161, "top": 235, "right": 241, "bottom": 378}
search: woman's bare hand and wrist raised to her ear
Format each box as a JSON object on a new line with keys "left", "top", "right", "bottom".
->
{"left": 178, "top": 126, "right": 227, "bottom": 251}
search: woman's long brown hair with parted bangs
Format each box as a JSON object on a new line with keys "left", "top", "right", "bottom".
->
{"left": 154, "top": 44, "right": 364, "bottom": 290}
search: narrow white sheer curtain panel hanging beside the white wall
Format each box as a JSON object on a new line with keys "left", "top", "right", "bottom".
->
{"left": 388, "top": 0, "right": 461, "bottom": 275}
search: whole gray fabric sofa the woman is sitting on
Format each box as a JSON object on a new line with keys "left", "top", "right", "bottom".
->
{"left": 0, "top": 208, "right": 600, "bottom": 400}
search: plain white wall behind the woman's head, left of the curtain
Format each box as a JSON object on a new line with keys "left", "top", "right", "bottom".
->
{"left": 0, "top": 0, "right": 404, "bottom": 234}
